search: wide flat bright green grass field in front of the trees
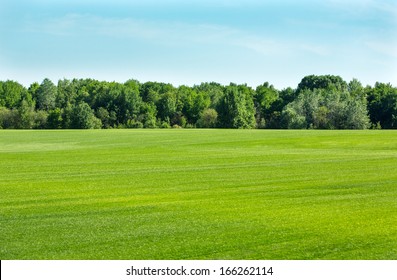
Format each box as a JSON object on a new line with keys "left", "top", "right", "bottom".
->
{"left": 0, "top": 130, "right": 397, "bottom": 259}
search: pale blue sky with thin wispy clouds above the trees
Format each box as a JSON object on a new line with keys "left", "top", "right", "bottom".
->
{"left": 0, "top": 0, "right": 397, "bottom": 89}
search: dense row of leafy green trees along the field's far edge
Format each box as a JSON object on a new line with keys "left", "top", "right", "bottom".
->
{"left": 0, "top": 75, "right": 397, "bottom": 129}
